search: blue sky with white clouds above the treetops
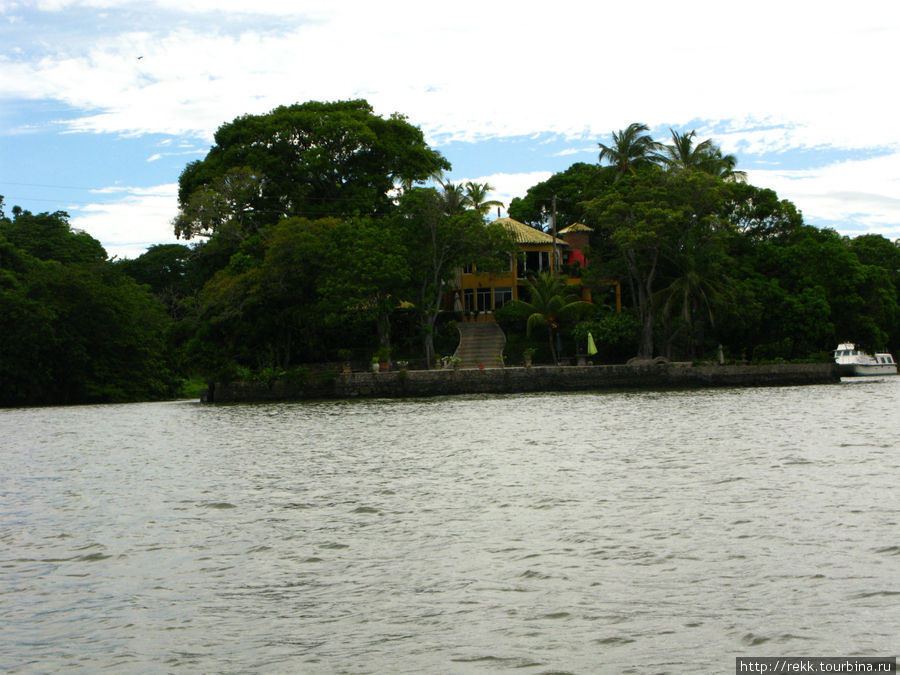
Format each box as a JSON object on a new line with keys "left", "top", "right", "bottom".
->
{"left": 0, "top": 0, "right": 900, "bottom": 258}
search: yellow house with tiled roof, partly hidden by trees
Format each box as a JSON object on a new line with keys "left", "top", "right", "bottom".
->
{"left": 445, "top": 218, "right": 591, "bottom": 321}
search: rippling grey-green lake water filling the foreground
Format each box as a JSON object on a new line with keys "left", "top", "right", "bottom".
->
{"left": 0, "top": 377, "right": 900, "bottom": 674}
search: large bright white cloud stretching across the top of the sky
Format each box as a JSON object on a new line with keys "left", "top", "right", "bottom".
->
{"left": 7, "top": 0, "right": 900, "bottom": 150}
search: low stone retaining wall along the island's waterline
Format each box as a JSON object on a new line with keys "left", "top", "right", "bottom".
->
{"left": 204, "top": 363, "right": 840, "bottom": 403}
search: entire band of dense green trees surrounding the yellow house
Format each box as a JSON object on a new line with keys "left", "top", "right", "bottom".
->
{"left": 0, "top": 108, "right": 900, "bottom": 405}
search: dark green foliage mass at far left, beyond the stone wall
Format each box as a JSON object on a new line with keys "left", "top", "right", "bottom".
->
{"left": 0, "top": 217, "right": 180, "bottom": 405}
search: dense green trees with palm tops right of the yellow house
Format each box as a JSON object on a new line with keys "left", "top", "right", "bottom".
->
{"left": 568, "top": 125, "right": 900, "bottom": 359}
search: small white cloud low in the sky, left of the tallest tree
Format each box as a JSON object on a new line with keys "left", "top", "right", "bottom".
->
{"left": 69, "top": 184, "right": 178, "bottom": 258}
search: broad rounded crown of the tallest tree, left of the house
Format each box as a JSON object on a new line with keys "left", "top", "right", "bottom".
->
{"left": 175, "top": 100, "right": 450, "bottom": 238}
